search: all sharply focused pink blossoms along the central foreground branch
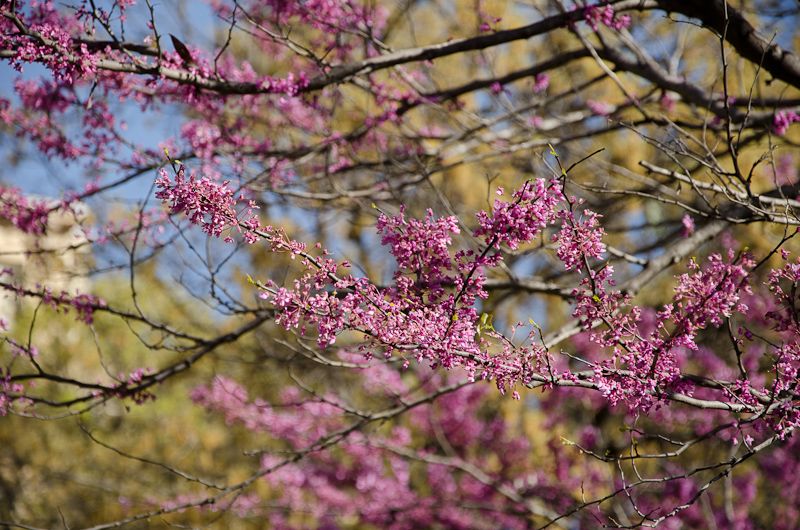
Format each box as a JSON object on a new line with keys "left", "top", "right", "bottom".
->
{"left": 159, "top": 162, "right": 797, "bottom": 434}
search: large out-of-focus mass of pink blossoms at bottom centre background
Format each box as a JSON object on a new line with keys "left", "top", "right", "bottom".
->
{"left": 192, "top": 368, "right": 548, "bottom": 530}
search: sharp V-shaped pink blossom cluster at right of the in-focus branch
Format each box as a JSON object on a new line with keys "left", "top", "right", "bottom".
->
{"left": 574, "top": 248, "right": 755, "bottom": 410}
